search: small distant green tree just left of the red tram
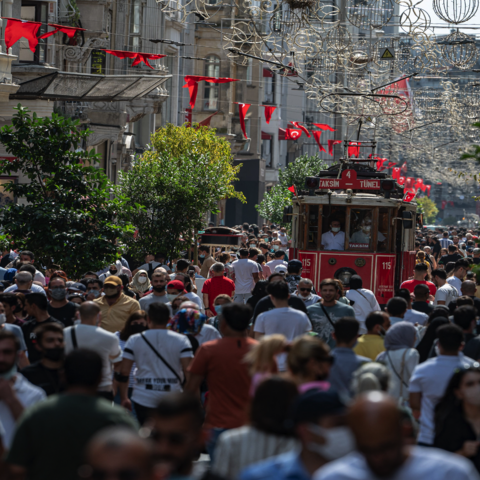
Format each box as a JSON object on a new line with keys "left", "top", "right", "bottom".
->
{"left": 255, "top": 155, "right": 327, "bottom": 223}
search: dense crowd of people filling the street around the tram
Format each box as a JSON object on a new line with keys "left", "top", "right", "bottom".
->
{"left": 0, "top": 224, "right": 480, "bottom": 480}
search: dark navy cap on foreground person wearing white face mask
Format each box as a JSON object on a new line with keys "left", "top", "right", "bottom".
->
{"left": 293, "top": 389, "right": 347, "bottom": 424}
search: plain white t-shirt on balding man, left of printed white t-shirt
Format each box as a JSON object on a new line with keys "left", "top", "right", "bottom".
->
{"left": 63, "top": 324, "right": 122, "bottom": 390}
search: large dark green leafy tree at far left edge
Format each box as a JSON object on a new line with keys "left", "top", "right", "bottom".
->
{"left": 0, "top": 104, "right": 134, "bottom": 278}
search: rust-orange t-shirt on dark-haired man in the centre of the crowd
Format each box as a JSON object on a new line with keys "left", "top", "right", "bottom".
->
{"left": 189, "top": 337, "right": 257, "bottom": 428}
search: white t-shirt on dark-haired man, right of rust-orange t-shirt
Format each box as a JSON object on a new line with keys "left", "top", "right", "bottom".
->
{"left": 254, "top": 307, "right": 312, "bottom": 372}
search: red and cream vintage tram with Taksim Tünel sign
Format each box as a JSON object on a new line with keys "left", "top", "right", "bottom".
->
{"left": 285, "top": 154, "right": 417, "bottom": 305}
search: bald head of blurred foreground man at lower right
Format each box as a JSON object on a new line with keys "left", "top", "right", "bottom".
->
{"left": 348, "top": 391, "right": 406, "bottom": 477}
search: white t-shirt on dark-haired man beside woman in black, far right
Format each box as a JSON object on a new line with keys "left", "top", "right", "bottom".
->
{"left": 408, "top": 353, "right": 475, "bottom": 444}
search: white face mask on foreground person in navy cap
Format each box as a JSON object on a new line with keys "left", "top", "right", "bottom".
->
{"left": 307, "top": 424, "right": 355, "bottom": 461}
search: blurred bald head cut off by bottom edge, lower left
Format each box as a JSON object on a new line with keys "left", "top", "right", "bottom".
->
{"left": 82, "top": 427, "right": 153, "bottom": 480}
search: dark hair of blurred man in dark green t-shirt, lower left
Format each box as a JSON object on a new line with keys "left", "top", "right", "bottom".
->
{"left": 64, "top": 348, "right": 103, "bottom": 388}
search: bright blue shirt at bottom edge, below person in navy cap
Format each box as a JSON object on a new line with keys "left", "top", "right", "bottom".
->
{"left": 238, "top": 452, "right": 311, "bottom": 480}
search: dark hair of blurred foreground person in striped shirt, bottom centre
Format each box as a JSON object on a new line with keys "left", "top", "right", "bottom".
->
{"left": 250, "top": 376, "right": 298, "bottom": 436}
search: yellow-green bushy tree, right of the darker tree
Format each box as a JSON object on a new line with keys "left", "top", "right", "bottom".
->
{"left": 116, "top": 124, "right": 245, "bottom": 257}
